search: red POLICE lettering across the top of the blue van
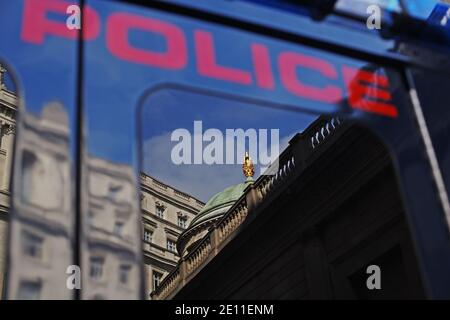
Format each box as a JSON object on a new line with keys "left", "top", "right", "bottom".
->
{"left": 22, "top": 0, "right": 398, "bottom": 117}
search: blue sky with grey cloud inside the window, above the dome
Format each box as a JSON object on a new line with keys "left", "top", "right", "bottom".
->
{"left": 140, "top": 90, "right": 317, "bottom": 201}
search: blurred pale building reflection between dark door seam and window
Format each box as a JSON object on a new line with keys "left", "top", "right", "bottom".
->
{"left": 81, "top": 157, "right": 141, "bottom": 300}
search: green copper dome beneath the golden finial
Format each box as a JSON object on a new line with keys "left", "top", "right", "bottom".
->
{"left": 189, "top": 178, "right": 253, "bottom": 228}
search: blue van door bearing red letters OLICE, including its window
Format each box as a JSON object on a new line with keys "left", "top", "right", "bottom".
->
{"left": 80, "top": 1, "right": 450, "bottom": 299}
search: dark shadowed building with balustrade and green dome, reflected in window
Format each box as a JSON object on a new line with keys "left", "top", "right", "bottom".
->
{"left": 152, "top": 117, "right": 424, "bottom": 300}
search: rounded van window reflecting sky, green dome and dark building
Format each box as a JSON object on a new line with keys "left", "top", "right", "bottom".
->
{"left": 138, "top": 88, "right": 424, "bottom": 299}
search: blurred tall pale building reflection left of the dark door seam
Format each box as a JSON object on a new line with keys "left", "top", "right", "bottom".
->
{"left": 8, "top": 102, "right": 73, "bottom": 299}
